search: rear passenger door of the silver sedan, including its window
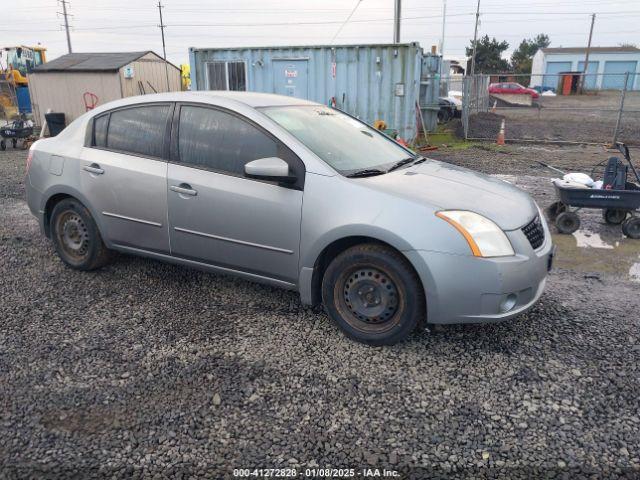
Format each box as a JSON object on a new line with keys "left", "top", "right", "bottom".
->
{"left": 79, "top": 103, "right": 173, "bottom": 253}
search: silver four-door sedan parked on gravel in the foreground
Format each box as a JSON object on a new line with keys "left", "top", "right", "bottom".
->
{"left": 26, "top": 92, "right": 552, "bottom": 345}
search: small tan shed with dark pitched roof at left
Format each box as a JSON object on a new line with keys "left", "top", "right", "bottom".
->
{"left": 29, "top": 51, "right": 181, "bottom": 124}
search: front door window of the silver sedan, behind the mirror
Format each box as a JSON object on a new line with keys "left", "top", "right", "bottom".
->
{"left": 178, "top": 105, "right": 282, "bottom": 175}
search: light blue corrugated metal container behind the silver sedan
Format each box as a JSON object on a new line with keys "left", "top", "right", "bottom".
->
{"left": 189, "top": 43, "right": 440, "bottom": 139}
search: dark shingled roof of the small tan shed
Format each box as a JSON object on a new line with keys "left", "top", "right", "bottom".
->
{"left": 34, "top": 50, "right": 178, "bottom": 72}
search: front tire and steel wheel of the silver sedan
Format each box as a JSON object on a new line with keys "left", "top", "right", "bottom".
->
{"left": 322, "top": 244, "right": 427, "bottom": 345}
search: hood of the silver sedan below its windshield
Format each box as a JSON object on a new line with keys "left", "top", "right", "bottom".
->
{"left": 358, "top": 160, "right": 538, "bottom": 230}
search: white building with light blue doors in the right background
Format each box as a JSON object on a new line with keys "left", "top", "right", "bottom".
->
{"left": 531, "top": 47, "right": 640, "bottom": 90}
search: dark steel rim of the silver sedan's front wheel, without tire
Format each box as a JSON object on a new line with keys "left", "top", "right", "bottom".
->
{"left": 343, "top": 267, "right": 400, "bottom": 329}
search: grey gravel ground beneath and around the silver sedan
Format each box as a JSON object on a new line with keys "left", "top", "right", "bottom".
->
{"left": 0, "top": 149, "right": 640, "bottom": 479}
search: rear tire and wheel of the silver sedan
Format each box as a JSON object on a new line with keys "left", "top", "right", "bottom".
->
{"left": 49, "top": 198, "right": 111, "bottom": 270}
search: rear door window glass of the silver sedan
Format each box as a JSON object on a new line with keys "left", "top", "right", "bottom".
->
{"left": 105, "top": 105, "right": 170, "bottom": 157}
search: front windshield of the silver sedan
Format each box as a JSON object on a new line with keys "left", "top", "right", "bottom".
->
{"left": 261, "top": 105, "right": 418, "bottom": 175}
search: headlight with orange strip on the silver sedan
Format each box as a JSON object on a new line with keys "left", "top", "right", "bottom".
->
{"left": 436, "top": 210, "right": 515, "bottom": 257}
